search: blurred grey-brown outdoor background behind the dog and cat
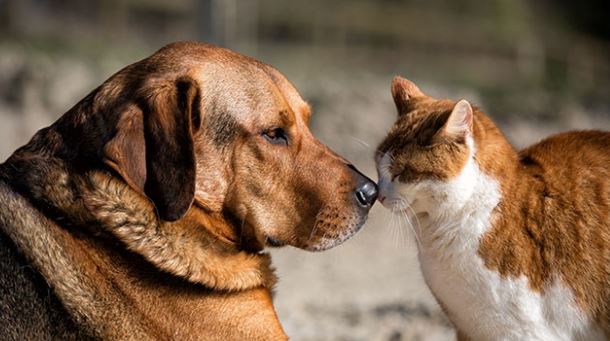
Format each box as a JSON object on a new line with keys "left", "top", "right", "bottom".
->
{"left": 0, "top": 0, "right": 610, "bottom": 341}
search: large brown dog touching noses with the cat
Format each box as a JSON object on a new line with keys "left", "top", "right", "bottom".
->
{"left": 0, "top": 42, "right": 377, "bottom": 340}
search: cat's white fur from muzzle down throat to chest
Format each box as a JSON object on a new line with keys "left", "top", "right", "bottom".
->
{"left": 378, "top": 149, "right": 605, "bottom": 340}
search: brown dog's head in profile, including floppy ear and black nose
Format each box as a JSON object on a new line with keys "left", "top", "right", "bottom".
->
{"left": 95, "top": 43, "right": 377, "bottom": 250}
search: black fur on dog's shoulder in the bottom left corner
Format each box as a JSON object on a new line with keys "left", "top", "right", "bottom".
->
{"left": 0, "top": 209, "right": 96, "bottom": 340}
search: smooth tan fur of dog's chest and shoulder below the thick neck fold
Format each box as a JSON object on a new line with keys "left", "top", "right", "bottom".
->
{"left": 0, "top": 174, "right": 286, "bottom": 340}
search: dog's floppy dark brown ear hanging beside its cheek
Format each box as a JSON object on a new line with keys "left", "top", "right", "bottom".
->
{"left": 104, "top": 77, "right": 201, "bottom": 221}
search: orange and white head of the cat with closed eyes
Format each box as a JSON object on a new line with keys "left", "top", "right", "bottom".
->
{"left": 375, "top": 77, "right": 477, "bottom": 214}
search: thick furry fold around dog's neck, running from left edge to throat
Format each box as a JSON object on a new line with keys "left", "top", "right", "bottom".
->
{"left": 0, "top": 151, "right": 276, "bottom": 291}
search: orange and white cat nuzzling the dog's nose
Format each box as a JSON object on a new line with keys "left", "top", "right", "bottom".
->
{"left": 376, "top": 77, "right": 610, "bottom": 340}
